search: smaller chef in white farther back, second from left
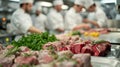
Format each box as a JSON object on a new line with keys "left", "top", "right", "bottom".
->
{"left": 33, "top": 5, "right": 47, "bottom": 32}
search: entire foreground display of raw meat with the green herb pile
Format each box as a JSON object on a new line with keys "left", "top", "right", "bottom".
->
{"left": 0, "top": 32, "right": 111, "bottom": 67}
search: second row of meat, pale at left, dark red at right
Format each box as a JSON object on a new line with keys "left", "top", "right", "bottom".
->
{"left": 43, "top": 37, "right": 111, "bottom": 56}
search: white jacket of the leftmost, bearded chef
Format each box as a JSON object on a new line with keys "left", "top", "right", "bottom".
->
{"left": 11, "top": 8, "right": 32, "bottom": 34}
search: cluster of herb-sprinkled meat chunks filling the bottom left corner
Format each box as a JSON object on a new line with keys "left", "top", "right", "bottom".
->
{"left": 0, "top": 46, "right": 39, "bottom": 67}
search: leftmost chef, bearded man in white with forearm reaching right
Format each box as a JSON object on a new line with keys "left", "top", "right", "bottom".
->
{"left": 11, "top": 0, "right": 41, "bottom": 34}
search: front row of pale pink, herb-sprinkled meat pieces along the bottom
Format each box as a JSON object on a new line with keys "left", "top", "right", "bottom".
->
{"left": 0, "top": 46, "right": 91, "bottom": 67}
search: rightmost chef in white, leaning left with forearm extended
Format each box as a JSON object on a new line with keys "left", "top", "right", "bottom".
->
{"left": 84, "top": 0, "right": 107, "bottom": 28}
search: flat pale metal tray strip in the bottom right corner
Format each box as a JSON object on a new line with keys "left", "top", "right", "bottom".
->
{"left": 91, "top": 57, "right": 120, "bottom": 67}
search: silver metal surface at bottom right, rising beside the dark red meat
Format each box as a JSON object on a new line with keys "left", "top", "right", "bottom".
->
{"left": 91, "top": 45, "right": 120, "bottom": 67}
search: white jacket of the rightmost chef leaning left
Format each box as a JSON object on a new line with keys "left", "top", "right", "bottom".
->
{"left": 88, "top": 7, "right": 107, "bottom": 27}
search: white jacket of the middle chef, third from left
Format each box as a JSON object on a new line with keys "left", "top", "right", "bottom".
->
{"left": 46, "top": 9, "right": 64, "bottom": 34}
